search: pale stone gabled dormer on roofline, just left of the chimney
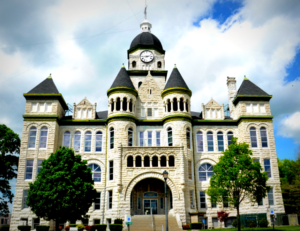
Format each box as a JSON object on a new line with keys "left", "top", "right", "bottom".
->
{"left": 202, "top": 98, "right": 225, "bottom": 120}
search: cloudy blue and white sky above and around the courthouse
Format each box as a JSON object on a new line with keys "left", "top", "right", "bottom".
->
{"left": 0, "top": 0, "right": 300, "bottom": 213}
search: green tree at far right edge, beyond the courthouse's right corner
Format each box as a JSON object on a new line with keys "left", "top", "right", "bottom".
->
{"left": 278, "top": 157, "right": 300, "bottom": 214}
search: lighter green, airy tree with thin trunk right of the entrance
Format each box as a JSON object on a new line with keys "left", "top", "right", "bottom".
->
{"left": 207, "top": 137, "right": 270, "bottom": 231}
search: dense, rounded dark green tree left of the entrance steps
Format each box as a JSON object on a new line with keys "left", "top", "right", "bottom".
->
{"left": 26, "top": 147, "right": 96, "bottom": 230}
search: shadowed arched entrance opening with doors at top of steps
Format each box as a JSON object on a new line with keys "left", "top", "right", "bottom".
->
{"left": 130, "top": 178, "right": 173, "bottom": 215}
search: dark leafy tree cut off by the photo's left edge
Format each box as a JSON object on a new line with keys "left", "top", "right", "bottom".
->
{"left": 0, "top": 124, "right": 20, "bottom": 216}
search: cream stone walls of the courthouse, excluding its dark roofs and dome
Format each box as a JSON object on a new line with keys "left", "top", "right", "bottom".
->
{"left": 11, "top": 18, "right": 284, "bottom": 231}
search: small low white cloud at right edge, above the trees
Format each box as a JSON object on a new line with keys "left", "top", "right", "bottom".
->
{"left": 278, "top": 111, "right": 300, "bottom": 143}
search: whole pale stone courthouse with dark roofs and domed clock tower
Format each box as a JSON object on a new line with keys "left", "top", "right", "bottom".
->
{"left": 11, "top": 20, "right": 284, "bottom": 231}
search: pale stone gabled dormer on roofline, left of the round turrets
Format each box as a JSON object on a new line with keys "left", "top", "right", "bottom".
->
{"left": 72, "top": 97, "right": 97, "bottom": 120}
